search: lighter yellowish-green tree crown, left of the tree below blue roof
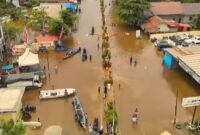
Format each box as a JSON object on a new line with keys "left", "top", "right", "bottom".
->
{"left": 28, "top": 10, "right": 50, "bottom": 29}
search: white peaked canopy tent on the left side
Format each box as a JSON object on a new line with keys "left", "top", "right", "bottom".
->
{"left": 18, "top": 48, "right": 39, "bottom": 67}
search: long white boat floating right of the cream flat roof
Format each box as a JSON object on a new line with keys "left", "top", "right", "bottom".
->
{"left": 39, "top": 88, "right": 76, "bottom": 99}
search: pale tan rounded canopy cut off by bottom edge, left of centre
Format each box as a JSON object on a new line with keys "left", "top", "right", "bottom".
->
{"left": 44, "top": 126, "right": 62, "bottom": 135}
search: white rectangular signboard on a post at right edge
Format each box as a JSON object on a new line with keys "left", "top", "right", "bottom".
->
{"left": 182, "top": 96, "right": 200, "bottom": 107}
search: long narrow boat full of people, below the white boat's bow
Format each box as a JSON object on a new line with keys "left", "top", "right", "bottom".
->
{"left": 72, "top": 96, "right": 87, "bottom": 128}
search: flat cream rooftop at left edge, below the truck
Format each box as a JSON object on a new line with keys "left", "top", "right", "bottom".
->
{"left": 0, "top": 88, "right": 25, "bottom": 113}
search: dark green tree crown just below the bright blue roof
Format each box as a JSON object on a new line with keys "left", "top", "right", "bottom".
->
{"left": 60, "top": 10, "right": 77, "bottom": 27}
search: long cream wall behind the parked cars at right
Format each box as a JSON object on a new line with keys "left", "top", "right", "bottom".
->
{"left": 150, "top": 31, "right": 200, "bottom": 39}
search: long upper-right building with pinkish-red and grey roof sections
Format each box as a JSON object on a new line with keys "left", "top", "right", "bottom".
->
{"left": 150, "top": 2, "right": 200, "bottom": 23}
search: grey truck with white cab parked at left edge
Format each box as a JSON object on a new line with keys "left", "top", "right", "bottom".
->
{"left": 0, "top": 72, "right": 42, "bottom": 88}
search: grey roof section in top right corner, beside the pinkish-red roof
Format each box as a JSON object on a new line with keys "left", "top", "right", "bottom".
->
{"left": 182, "top": 3, "right": 200, "bottom": 15}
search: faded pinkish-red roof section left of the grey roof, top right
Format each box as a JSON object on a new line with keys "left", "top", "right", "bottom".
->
{"left": 151, "top": 2, "right": 184, "bottom": 15}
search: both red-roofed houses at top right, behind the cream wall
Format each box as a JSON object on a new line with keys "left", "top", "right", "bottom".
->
{"left": 141, "top": 2, "right": 200, "bottom": 34}
